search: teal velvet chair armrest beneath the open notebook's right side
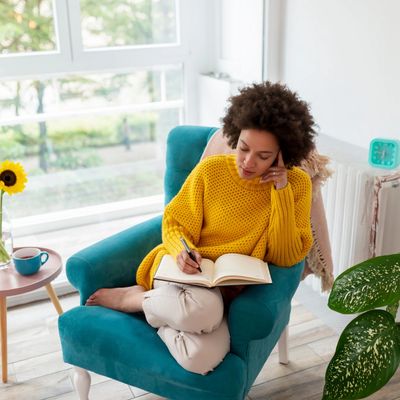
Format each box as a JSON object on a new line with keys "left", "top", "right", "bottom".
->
{"left": 228, "top": 261, "right": 304, "bottom": 356}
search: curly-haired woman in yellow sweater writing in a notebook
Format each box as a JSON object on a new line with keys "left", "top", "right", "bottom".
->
{"left": 86, "top": 82, "right": 315, "bottom": 374}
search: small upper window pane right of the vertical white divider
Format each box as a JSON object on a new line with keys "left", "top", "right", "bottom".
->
{"left": 80, "top": 0, "right": 177, "bottom": 48}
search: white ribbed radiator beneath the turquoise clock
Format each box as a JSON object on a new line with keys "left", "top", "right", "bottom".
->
{"left": 305, "top": 135, "right": 400, "bottom": 295}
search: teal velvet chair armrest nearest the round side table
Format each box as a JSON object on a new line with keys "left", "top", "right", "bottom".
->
{"left": 66, "top": 215, "right": 162, "bottom": 304}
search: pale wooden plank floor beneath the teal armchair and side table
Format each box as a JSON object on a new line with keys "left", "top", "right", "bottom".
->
{"left": 0, "top": 295, "right": 400, "bottom": 400}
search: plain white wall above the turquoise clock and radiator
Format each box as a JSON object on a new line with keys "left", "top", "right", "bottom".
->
{"left": 280, "top": 0, "right": 400, "bottom": 148}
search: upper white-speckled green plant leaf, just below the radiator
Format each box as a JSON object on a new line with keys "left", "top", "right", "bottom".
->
{"left": 328, "top": 253, "right": 400, "bottom": 314}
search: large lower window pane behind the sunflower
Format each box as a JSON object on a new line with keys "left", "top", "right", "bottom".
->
{"left": 0, "top": 67, "right": 183, "bottom": 218}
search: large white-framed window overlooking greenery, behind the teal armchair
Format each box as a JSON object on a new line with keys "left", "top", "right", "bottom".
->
{"left": 0, "top": 0, "right": 200, "bottom": 282}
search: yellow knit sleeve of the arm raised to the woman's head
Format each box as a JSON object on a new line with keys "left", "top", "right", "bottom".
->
{"left": 266, "top": 169, "right": 313, "bottom": 266}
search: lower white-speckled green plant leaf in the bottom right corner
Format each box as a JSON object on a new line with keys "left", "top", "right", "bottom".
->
{"left": 323, "top": 310, "right": 400, "bottom": 400}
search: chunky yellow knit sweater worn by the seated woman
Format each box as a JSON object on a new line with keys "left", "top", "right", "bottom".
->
{"left": 136, "top": 154, "right": 312, "bottom": 289}
